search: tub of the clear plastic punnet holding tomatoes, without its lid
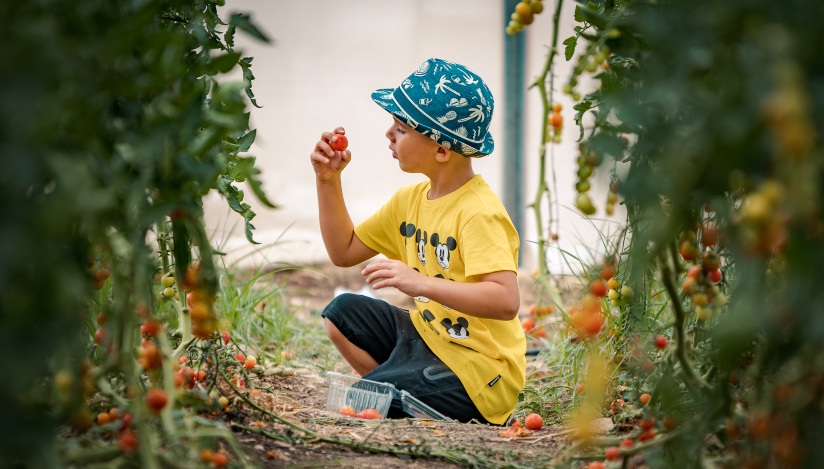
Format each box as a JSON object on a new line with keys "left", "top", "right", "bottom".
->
{"left": 326, "top": 371, "right": 398, "bottom": 418}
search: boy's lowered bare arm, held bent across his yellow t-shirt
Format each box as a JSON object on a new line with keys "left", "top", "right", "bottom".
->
{"left": 361, "top": 259, "right": 521, "bottom": 321}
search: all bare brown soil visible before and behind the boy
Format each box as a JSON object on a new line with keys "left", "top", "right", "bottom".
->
{"left": 220, "top": 265, "right": 588, "bottom": 468}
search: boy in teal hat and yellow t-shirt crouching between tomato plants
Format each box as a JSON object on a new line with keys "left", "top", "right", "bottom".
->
{"left": 311, "top": 59, "right": 526, "bottom": 425}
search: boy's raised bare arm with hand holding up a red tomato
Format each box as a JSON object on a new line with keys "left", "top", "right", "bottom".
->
{"left": 311, "top": 127, "right": 377, "bottom": 267}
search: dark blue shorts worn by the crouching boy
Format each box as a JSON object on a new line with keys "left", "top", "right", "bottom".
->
{"left": 323, "top": 293, "right": 488, "bottom": 423}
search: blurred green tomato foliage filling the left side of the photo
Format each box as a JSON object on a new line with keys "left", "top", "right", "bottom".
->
{"left": 0, "top": 0, "right": 272, "bottom": 467}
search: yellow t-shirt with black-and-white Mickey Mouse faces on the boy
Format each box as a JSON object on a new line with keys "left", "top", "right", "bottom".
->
{"left": 355, "top": 175, "right": 526, "bottom": 424}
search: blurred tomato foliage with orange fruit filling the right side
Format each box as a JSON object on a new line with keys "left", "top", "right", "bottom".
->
{"left": 513, "top": 0, "right": 824, "bottom": 468}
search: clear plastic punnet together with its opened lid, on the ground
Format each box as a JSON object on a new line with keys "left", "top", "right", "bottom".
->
{"left": 326, "top": 371, "right": 453, "bottom": 422}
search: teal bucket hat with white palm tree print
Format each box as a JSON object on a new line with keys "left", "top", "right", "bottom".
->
{"left": 372, "top": 59, "right": 495, "bottom": 157}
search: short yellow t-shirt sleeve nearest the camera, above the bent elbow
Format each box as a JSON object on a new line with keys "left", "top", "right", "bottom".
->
{"left": 460, "top": 211, "right": 520, "bottom": 277}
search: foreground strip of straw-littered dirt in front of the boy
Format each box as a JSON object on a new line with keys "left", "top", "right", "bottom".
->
{"left": 220, "top": 372, "right": 567, "bottom": 468}
